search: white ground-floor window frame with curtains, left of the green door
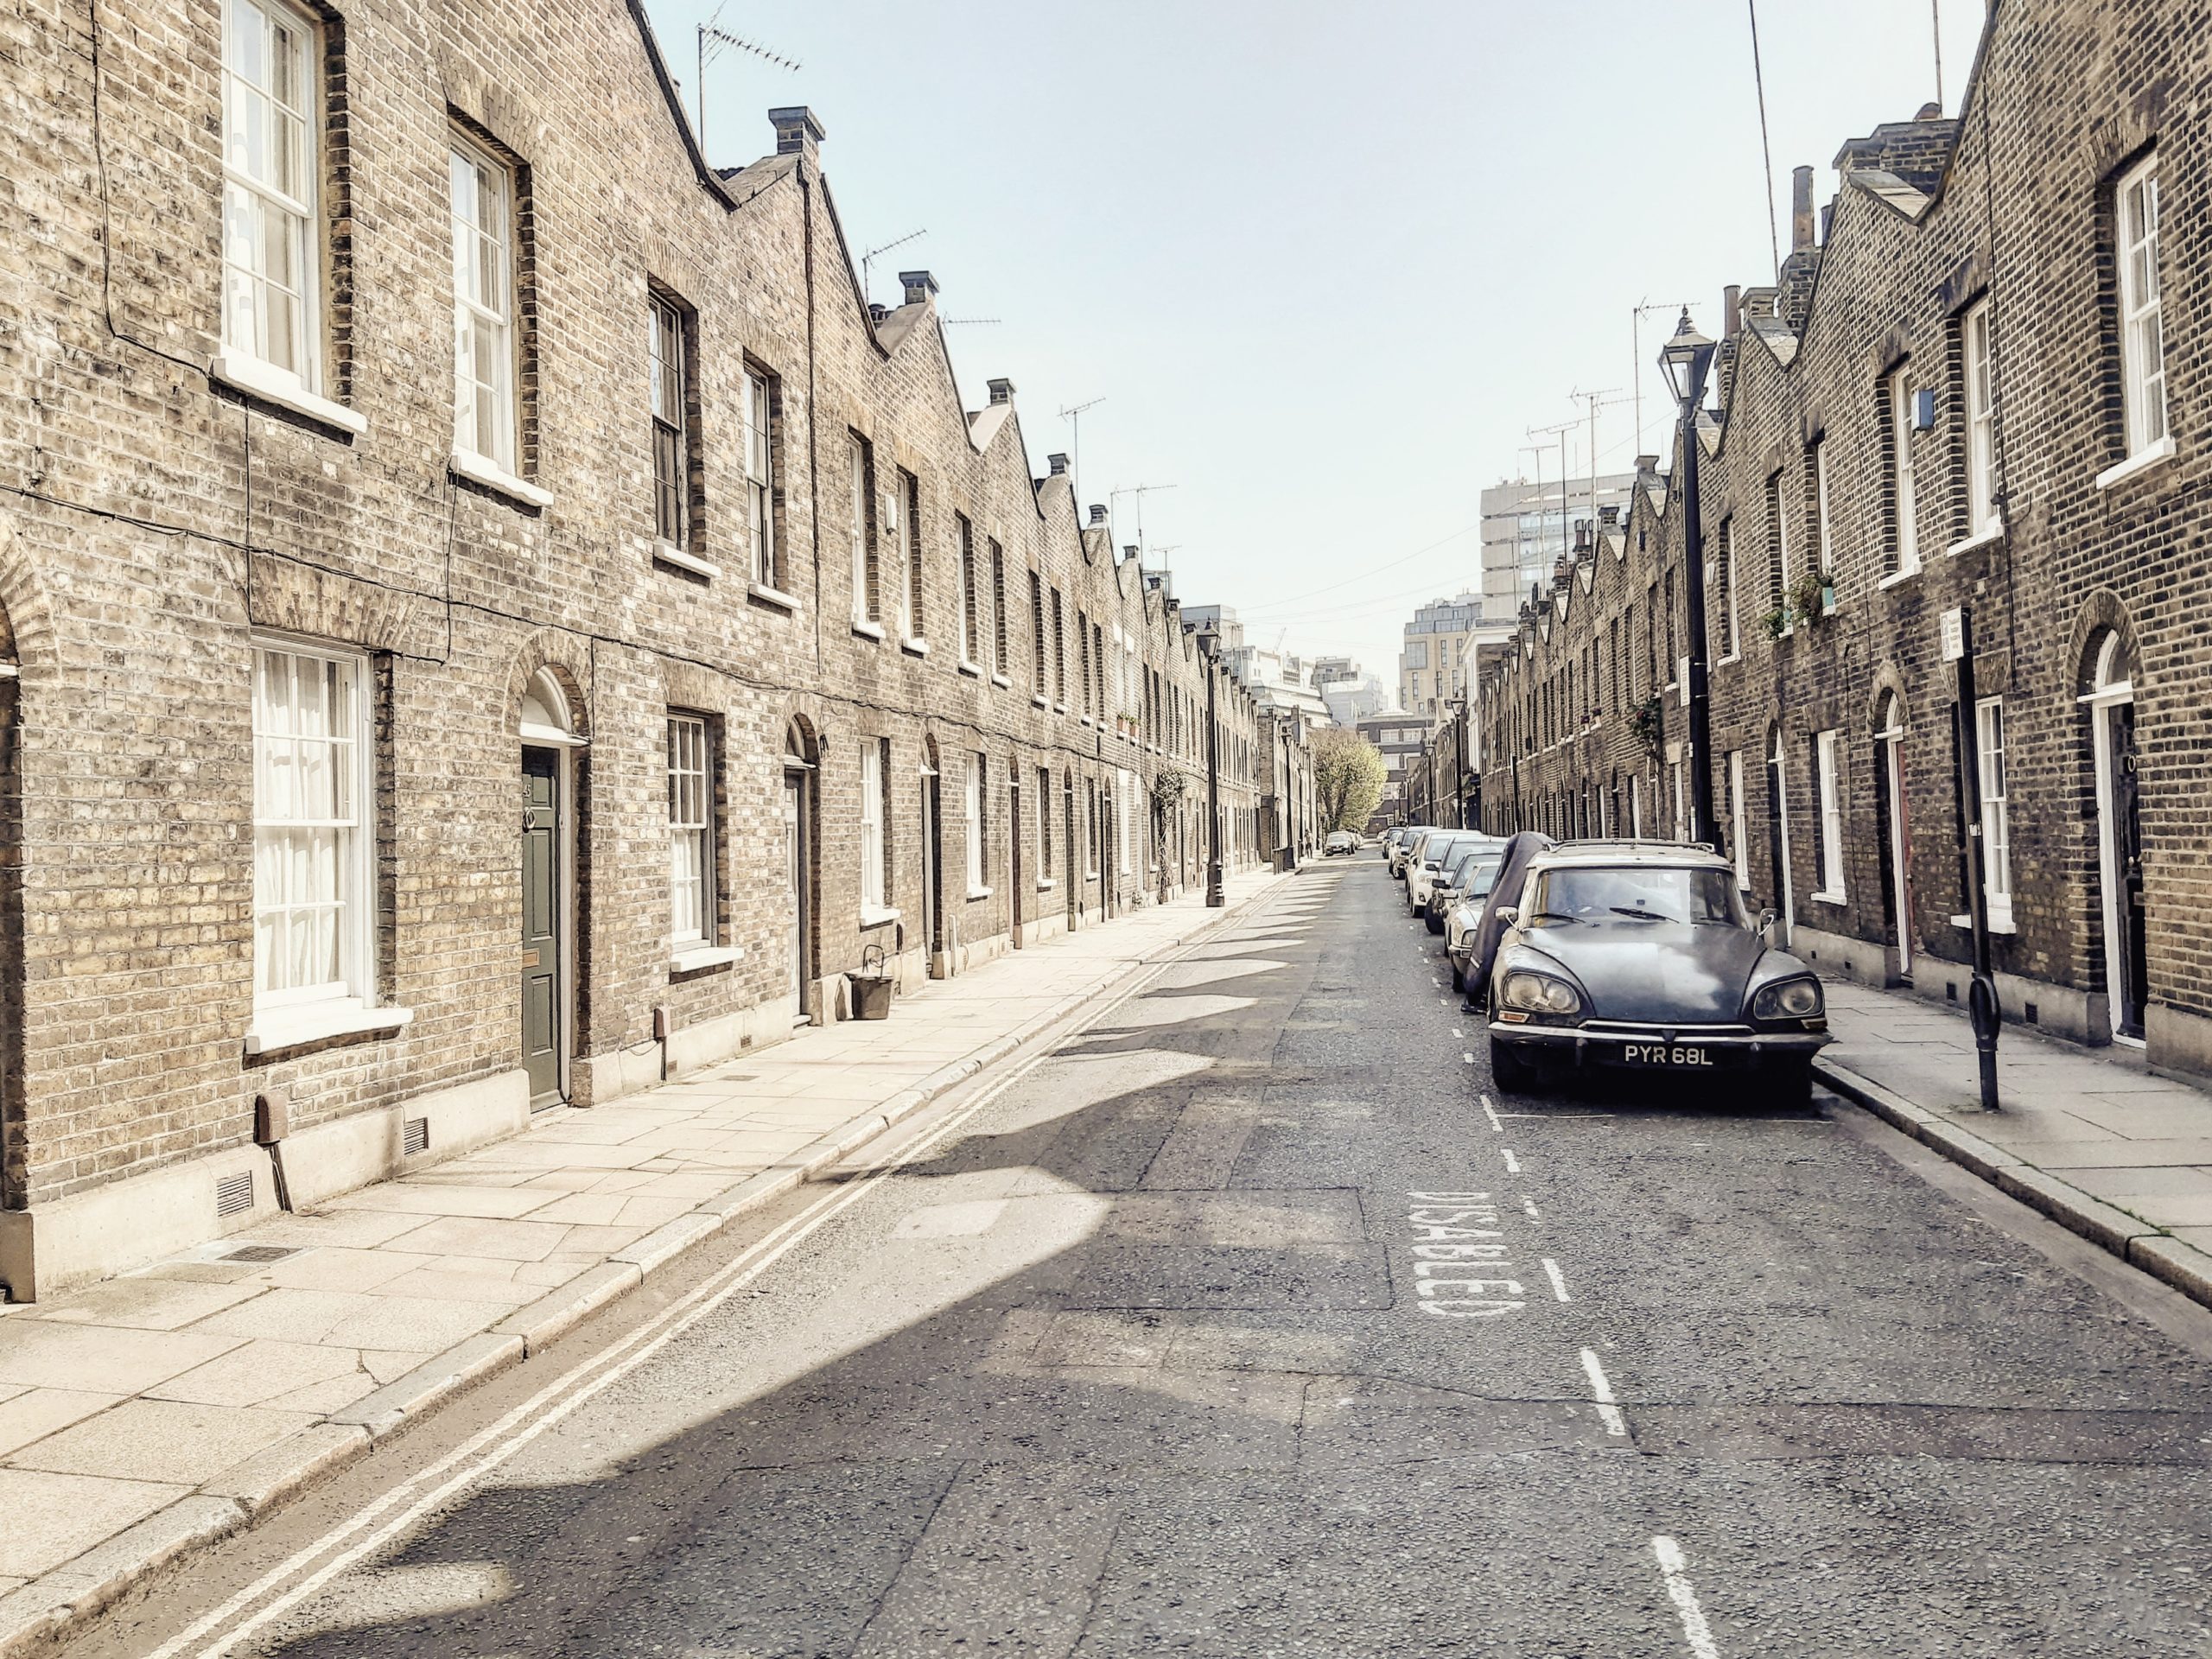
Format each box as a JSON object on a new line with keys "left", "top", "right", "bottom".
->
{"left": 252, "top": 635, "right": 376, "bottom": 1022}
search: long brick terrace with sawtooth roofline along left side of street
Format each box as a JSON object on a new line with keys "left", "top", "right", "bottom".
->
{"left": 0, "top": 0, "right": 1310, "bottom": 1299}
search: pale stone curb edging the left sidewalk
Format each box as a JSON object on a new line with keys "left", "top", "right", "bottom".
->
{"left": 0, "top": 885, "right": 1282, "bottom": 1659}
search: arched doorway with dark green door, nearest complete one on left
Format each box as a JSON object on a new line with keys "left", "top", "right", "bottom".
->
{"left": 515, "top": 668, "right": 584, "bottom": 1110}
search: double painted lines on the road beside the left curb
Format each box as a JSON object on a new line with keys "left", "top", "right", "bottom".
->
{"left": 146, "top": 1000, "right": 1088, "bottom": 1659}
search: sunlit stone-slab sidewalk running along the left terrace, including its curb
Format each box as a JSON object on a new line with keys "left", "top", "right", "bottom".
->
{"left": 0, "top": 872, "right": 1287, "bottom": 1655}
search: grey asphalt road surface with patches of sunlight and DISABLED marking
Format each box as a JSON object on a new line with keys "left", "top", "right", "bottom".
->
{"left": 78, "top": 854, "right": 2212, "bottom": 1659}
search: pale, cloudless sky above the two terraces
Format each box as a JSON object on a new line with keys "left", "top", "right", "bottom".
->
{"left": 648, "top": 0, "right": 1982, "bottom": 686}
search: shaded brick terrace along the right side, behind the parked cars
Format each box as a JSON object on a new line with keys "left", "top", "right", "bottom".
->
{"left": 1478, "top": 0, "right": 2212, "bottom": 1073}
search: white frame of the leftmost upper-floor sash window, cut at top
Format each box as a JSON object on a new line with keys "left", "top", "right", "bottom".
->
{"left": 221, "top": 0, "right": 323, "bottom": 396}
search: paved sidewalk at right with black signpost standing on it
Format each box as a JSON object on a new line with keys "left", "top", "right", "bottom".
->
{"left": 1814, "top": 980, "right": 2212, "bottom": 1318}
